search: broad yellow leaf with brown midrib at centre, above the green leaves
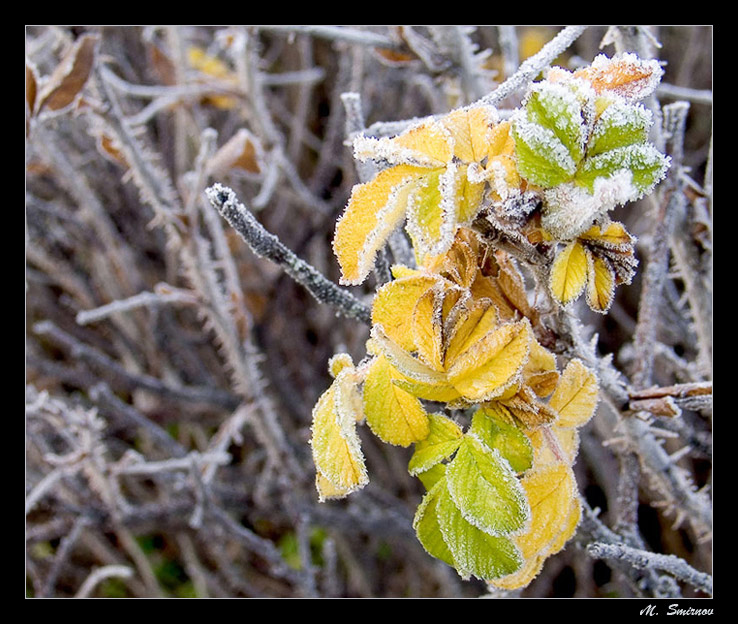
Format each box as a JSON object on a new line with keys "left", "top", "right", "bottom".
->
{"left": 447, "top": 319, "right": 531, "bottom": 401}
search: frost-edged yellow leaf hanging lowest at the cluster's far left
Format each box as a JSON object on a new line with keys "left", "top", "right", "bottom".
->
{"left": 310, "top": 372, "right": 369, "bottom": 497}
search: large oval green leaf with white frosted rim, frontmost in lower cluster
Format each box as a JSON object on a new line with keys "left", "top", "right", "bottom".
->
{"left": 446, "top": 434, "right": 530, "bottom": 536}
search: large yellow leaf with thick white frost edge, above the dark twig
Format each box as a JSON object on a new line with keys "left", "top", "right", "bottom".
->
{"left": 333, "top": 165, "right": 428, "bottom": 284}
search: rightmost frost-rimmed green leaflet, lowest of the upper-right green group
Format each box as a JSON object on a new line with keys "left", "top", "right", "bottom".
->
{"left": 575, "top": 143, "right": 669, "bottom": 194}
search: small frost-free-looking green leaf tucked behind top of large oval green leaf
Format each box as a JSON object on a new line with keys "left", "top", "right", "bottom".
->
{"left": 470, "top": 402, "right": 533, "bottom": 473}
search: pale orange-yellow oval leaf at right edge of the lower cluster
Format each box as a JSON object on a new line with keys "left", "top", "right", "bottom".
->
{"left": 548, "top": 360, "right": 599, "bottom": 427}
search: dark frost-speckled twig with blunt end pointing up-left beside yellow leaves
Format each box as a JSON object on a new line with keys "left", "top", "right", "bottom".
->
{"left": 206, "top": 184, "right": 371, "bottom": 324}
